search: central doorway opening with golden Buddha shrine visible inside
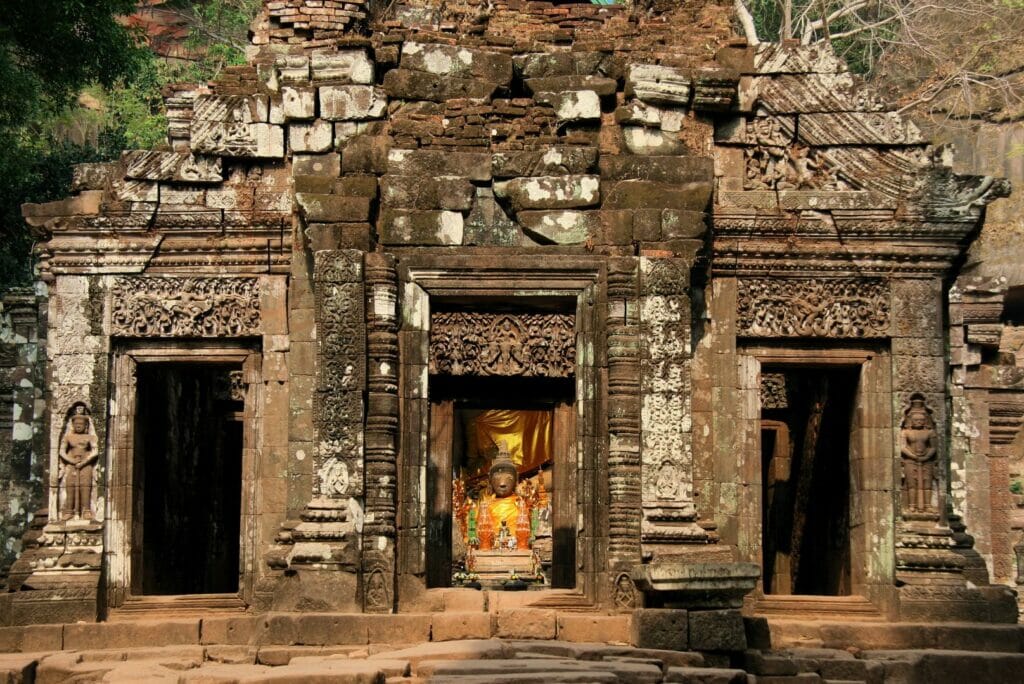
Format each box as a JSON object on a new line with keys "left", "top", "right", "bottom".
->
{"left": 427, "top": 376, "right": 578, "bottom": 589}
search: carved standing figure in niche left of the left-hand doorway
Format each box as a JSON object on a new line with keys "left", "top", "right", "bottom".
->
{"left": 58, "top": 402, "right": 99, "bottom": 520}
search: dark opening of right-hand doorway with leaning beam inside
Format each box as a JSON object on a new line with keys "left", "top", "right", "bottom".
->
{"left": 761, "top": 367, "right": 860, "bottom": 596}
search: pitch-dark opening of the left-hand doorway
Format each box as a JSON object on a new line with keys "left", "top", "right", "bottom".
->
{"left": 132, "top": 362, "right": 244, "bottom": 595}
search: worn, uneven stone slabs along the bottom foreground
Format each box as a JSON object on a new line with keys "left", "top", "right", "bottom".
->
{"left": 6, "top": 639, "right": 1024, "bottom": 684}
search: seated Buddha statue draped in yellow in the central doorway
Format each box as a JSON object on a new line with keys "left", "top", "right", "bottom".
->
{"left": 475, "top": 442, "right": 530, "bottom": 550}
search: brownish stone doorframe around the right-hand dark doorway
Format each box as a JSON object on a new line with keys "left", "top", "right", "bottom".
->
{"left": 737, "top": 343, "right": 899, "bottom": 615}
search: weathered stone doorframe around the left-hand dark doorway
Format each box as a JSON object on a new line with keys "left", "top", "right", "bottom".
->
{"left": 104, "top": 340, "right": 263, "bottom": 609}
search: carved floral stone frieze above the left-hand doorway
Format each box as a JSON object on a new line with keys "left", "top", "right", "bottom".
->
{"left": 111, "top": 277, "right": 261, "bottom": 337}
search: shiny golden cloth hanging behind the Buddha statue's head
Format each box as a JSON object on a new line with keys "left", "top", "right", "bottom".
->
{"left": 473, "top": 409, "right": 552, "bottom": 473}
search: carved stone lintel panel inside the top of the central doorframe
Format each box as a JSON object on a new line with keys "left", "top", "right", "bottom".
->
{"left": 430, "top": 311, "right": 575, "bottom": 378}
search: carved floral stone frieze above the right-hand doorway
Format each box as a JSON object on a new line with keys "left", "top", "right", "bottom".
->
{"left": 736, "top": 279, "right": 890, "bottom": 338}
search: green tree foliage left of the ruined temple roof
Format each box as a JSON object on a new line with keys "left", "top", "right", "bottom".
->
{"left": 0, "top": 0, "right": 260, "bottom": 293}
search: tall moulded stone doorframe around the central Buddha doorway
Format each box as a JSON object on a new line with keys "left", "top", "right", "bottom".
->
{"left": 397, "top": 256, "right": 606, "bottom": 606}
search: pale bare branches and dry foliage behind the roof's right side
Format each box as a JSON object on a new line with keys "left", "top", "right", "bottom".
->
{"left": 733, "top": 0, "right": 1024, "bottom": 118}
